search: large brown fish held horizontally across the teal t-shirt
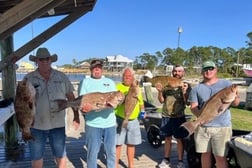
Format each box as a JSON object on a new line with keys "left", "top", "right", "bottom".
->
{"left": 54, "top": 91, "right": 125, "bottom": 112}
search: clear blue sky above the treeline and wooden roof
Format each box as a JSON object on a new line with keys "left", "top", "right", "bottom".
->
{"left": 14, "top": 0, "right": 252, "bottom": 65}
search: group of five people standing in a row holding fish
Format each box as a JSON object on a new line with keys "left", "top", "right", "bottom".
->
{"left": 25, "top": 48, "right": 239, "bottom": 168}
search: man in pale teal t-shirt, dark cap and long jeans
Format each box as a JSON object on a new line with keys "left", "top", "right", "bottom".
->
{"left": 78, "top": 60, "right": 116, "bottom": 168}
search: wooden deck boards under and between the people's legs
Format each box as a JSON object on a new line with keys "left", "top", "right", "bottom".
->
{"left": 0, "top": 126, "right": 187, "bottom": 168}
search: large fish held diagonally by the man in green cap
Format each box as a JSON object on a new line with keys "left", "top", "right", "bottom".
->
{"left": 181, "top": 84, "right": 238, "bottom": 135}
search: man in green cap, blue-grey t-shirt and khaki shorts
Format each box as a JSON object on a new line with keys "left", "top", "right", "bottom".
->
{"left": 189, "top": 60, "right": 240, "bottom": 168}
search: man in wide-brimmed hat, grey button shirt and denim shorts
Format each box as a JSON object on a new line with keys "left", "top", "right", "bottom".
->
{"left": 24, "top": 48, "right": 80, "bottom": 168}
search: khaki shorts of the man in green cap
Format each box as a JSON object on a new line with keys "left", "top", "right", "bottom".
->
{"left": 194, "top": 127, "right": 232, "bottom": 157}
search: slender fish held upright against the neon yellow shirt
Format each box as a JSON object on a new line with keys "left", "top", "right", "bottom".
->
{"left": 122, "top": 80, "right": 139, "bottom": 128}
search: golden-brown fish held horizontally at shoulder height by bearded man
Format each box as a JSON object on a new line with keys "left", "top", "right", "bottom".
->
{"left": 143, "top": 76, "right": 183, "bottom": 88}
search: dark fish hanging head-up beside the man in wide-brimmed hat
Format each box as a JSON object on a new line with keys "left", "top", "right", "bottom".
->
{"left": 14, "top": 79, "right": 36, "bottom": 141}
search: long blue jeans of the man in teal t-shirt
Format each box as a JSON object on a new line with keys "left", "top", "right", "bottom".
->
{"left": 85, "top": 125, "right": 116, "bottom": 168}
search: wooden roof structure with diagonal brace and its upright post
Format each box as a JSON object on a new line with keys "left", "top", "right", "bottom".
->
{"left": 0, "top": 0, "right": 96, "bottom": 146}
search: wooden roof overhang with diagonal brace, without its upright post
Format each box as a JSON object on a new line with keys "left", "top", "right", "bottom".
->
{"left": 0, "top": 0, "right": 96, "bottom": 71}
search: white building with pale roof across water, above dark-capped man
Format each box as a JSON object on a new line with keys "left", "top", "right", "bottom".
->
{"left": 104, "top": 54, "right": 133, "bottom": 72}
